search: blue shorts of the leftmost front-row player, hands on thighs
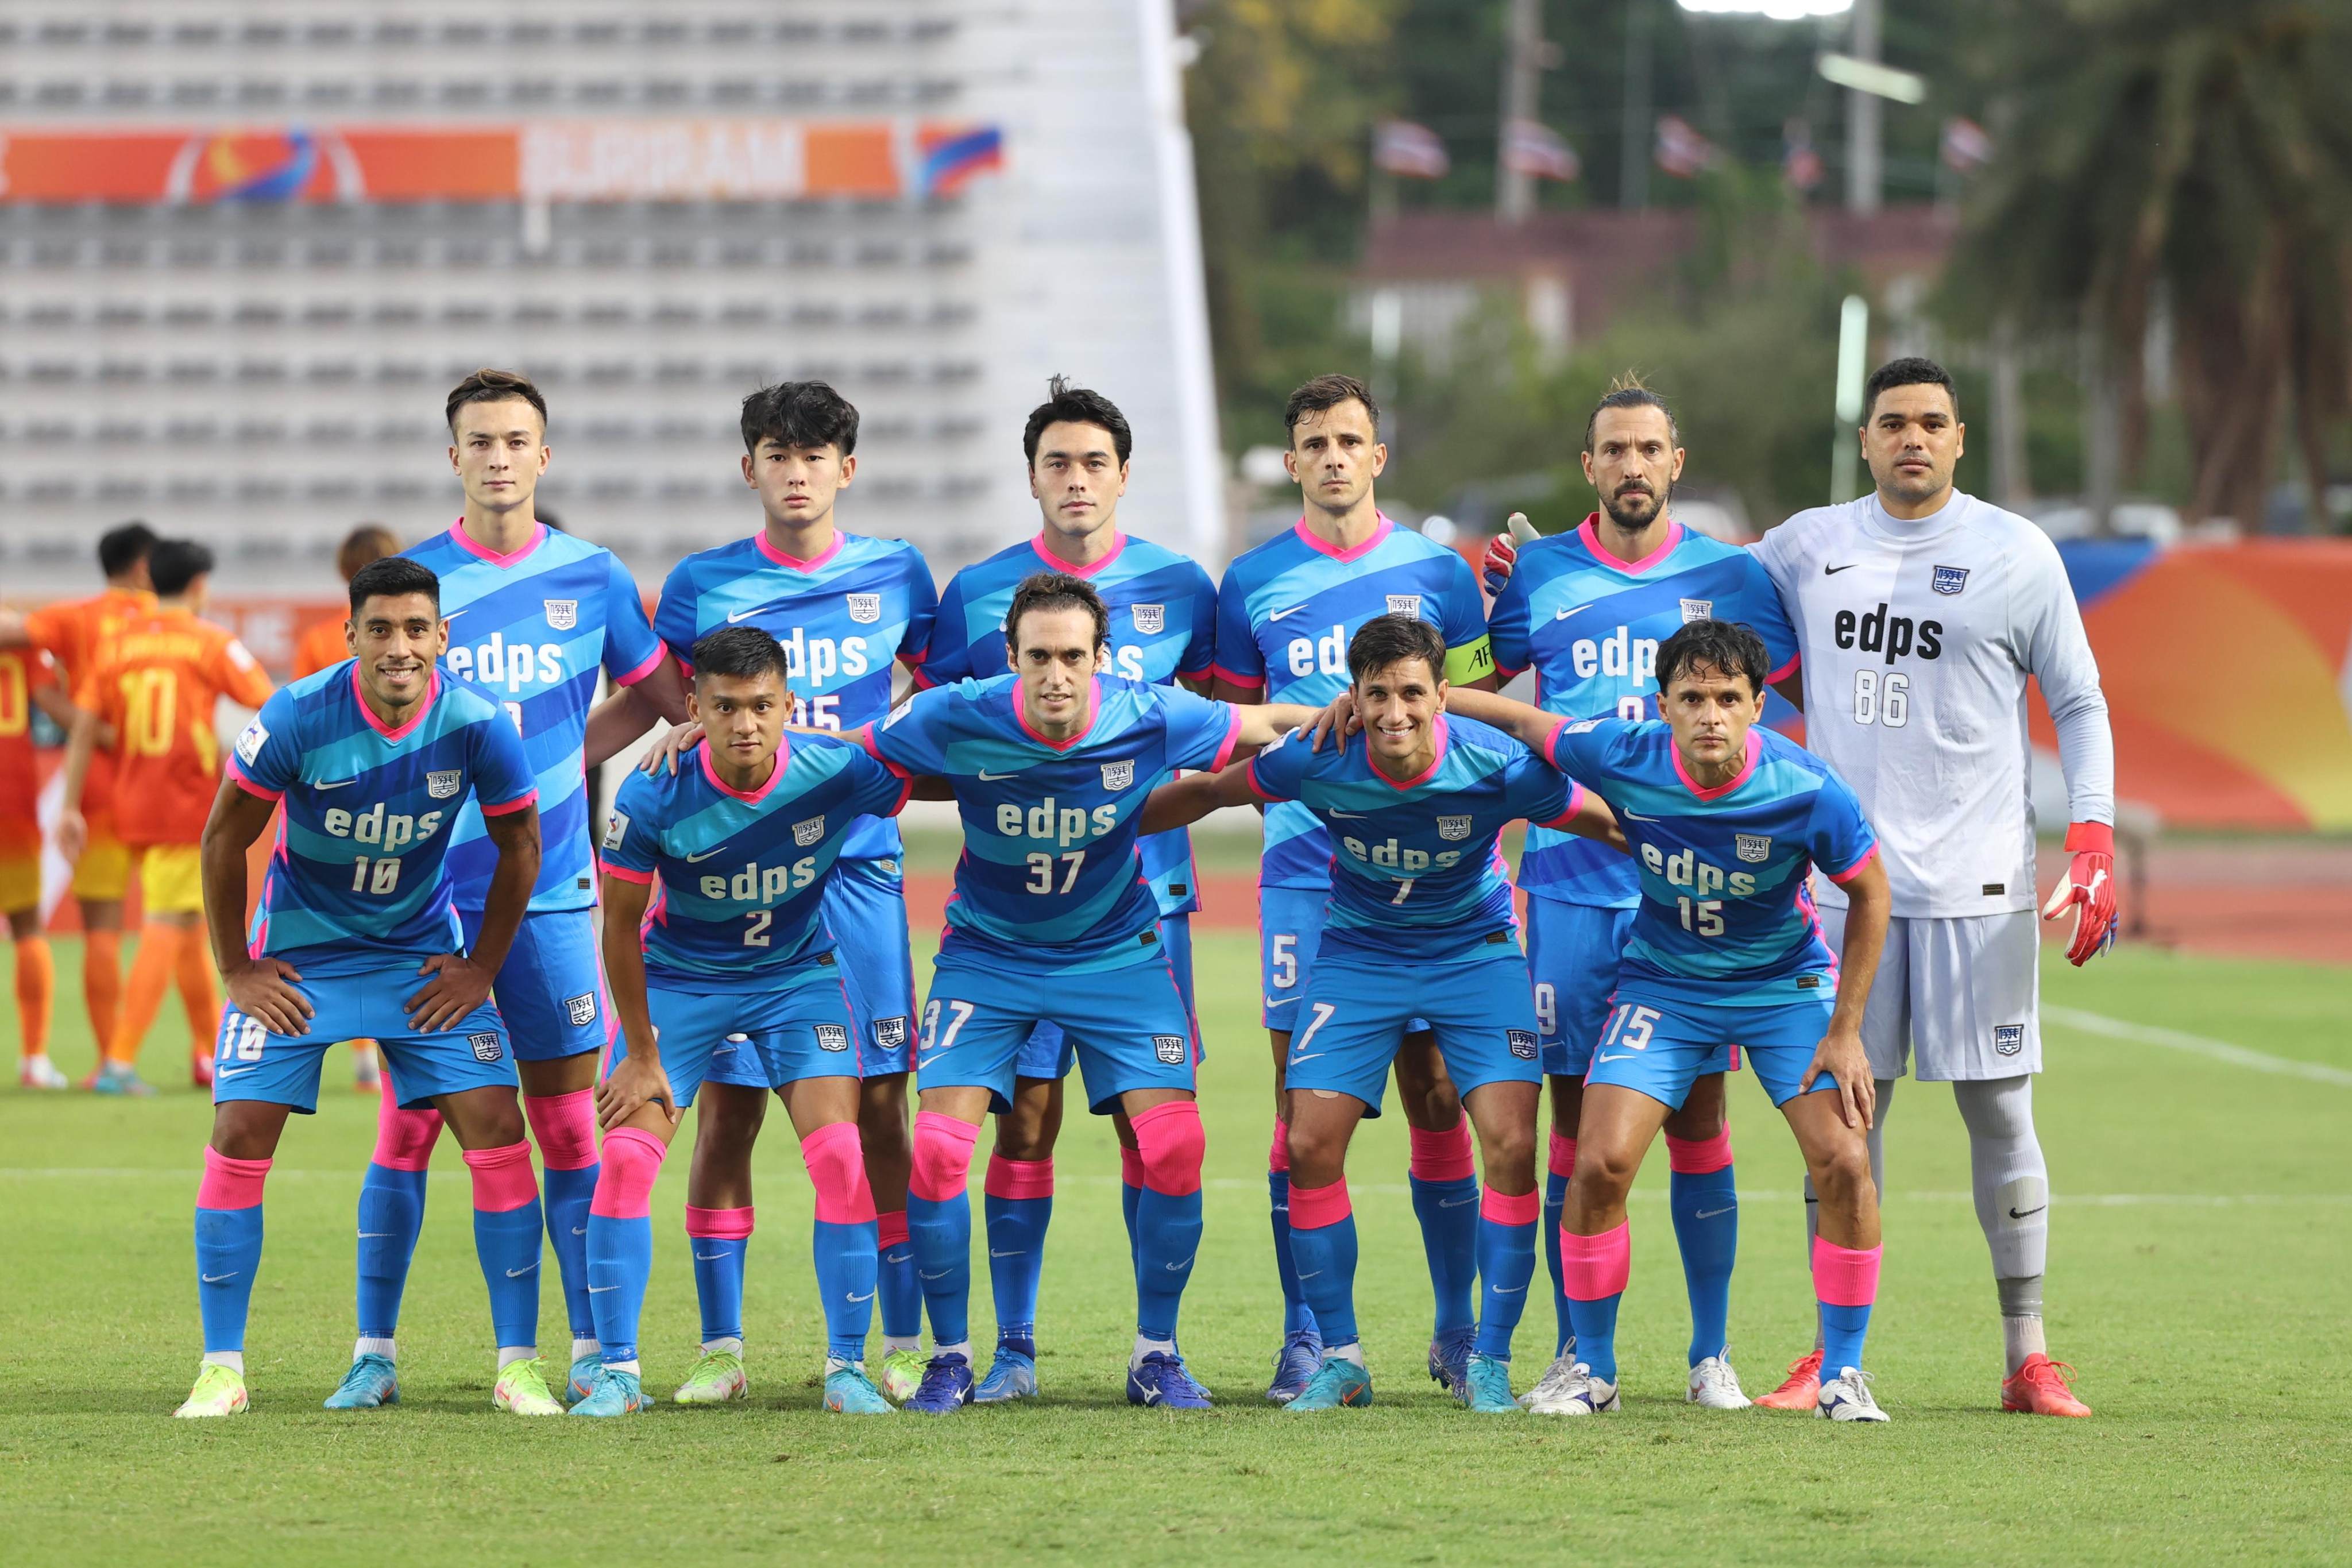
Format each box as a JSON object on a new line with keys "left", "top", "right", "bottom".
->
{"left": 212, "top": 955, "right": 515, "bottom": 1114}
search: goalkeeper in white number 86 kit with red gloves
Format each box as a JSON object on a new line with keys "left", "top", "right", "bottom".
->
{"left": 1757, "top": 360, "right": 2117, "bottom": 1415}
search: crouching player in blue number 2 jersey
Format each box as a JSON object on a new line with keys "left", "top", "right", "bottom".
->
{"left": 571, "top": 625, "right": 913, "bottom": 1415}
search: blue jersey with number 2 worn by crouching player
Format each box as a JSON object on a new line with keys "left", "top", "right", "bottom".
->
{"left": 602, "top": 736, "right": 910, "bottom": 990}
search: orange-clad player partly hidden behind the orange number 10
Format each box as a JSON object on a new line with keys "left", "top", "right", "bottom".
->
{"left": 0, "top": 522, "right": 155, "bottom": 1053}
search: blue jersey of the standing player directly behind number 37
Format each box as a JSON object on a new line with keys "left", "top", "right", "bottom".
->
{"left": 915, "top": 534, "right": 1216, "bottom": 914}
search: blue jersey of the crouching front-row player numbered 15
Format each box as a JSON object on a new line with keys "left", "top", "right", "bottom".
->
{"left": 1545, "top": 719, "right": 1879, "bottom": 1006}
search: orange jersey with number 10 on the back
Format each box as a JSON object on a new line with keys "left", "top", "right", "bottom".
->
{"left": 80, "top": 609, "right": 271, "bottom": 844}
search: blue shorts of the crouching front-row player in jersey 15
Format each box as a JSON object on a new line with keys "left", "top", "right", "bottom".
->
{"left": 1585, "top": 976, "right": 1837, "bottom": 1110}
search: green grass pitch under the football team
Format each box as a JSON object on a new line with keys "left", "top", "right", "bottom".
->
{"left": 0, "top": 933, "right": 2352, "bottom": 1568}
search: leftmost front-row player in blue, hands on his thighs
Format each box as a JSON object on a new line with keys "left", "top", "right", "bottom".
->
{"left": 179, "top": 557, "right": 565, "bottom": 1415}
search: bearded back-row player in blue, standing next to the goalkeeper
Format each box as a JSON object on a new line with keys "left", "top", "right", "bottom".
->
{"left": 1489, "top": 376, "right": 1797, "bottom": 1413}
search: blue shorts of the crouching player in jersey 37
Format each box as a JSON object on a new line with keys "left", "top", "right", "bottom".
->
{"left": 915, "top": 945, "right": 1195, "bottom": 1117}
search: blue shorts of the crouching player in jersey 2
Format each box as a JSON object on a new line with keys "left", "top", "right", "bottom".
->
{"left": 644, "top": 955, "right": 861, "bottom": 1110}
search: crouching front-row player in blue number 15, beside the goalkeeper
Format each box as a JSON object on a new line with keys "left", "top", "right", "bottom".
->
{"left": 1446, "top": 621, "right": 1891, "bottom": 1422}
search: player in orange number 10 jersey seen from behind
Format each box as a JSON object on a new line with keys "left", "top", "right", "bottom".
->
{"left": 59, "top": 538, "right": 271, "bottom": 1093}
